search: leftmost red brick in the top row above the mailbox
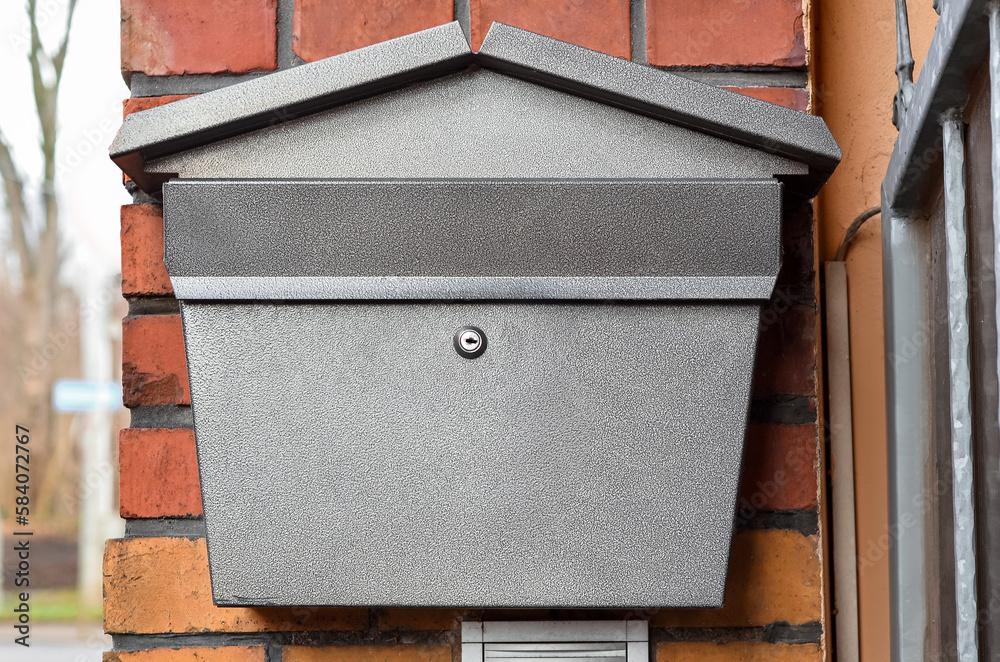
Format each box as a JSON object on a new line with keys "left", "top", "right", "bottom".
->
{"left": 122, "top": 0, "right": 278, "bottom": 76}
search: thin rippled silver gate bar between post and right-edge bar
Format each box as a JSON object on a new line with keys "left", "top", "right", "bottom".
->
{"left": 942, "top": 110, "right": 979, "bottom": 662}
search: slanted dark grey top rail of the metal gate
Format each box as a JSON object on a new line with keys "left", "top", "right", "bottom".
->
{"left": 882, "top": 0, "right": 989, "bottom": 213}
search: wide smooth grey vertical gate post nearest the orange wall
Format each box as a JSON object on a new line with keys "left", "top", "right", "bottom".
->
{"left": 882, "top": 202, "right": 934, "bottom": 662}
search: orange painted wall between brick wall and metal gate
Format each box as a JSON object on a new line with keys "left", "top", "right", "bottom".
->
{"left": 813, "top": 0, "right": 938, "bottom": 662}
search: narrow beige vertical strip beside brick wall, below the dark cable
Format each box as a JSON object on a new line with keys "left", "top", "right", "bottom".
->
{"left": 825, "top": 262, "right": 860, "bottom": 662}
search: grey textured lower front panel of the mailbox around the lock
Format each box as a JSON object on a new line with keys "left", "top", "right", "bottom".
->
{"left": 182, "top": 302, "right": 759, "bottom": 607}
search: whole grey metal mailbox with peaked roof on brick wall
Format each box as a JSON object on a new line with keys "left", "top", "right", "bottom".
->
{"left": 112, "top": 24, "right": 840, "bottom": 607}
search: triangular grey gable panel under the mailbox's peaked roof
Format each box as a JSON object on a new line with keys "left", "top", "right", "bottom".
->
{"left": 147, "top": 67, "right": 807, "bottom": 179}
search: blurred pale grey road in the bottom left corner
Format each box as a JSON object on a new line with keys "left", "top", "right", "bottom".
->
{"left": 0, "top": 622, "right": 111, "bottom": 662}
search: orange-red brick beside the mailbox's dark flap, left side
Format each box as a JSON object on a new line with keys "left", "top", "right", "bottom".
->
{"left": 121, "top": 205, "right": 174, "bottom": 297}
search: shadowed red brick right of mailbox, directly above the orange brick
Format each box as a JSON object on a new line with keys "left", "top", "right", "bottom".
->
{"left": 738, "top": 423, "right": 819, "bottom": 518}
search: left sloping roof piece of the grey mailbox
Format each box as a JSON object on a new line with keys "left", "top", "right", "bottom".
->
{"left": 111, "top": 23, "right": 472, "bottom": 191}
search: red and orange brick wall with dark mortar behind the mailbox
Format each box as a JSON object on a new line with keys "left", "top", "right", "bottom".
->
{"left": 113, "top": 0, "right": 827, "bottom": 662}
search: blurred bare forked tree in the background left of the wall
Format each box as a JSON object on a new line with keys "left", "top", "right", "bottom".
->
{"left": 0, "top": 0, "right": 79, "bottom": 518}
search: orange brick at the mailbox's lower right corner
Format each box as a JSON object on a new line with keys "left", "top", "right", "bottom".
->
{"left": 651, "top": 530, "right": 823, "bottom": 628}
